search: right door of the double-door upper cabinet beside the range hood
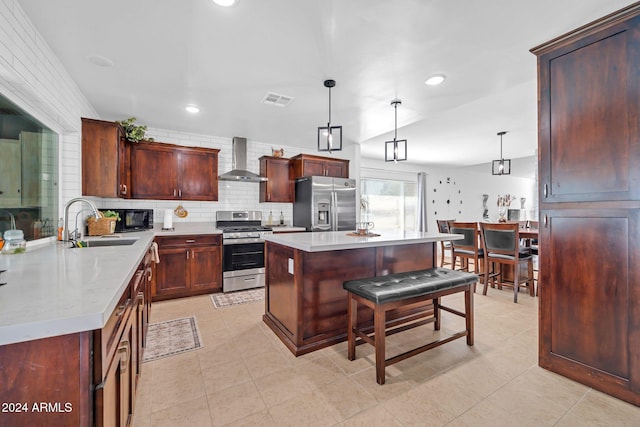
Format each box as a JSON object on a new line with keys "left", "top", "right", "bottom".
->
{"left": 176, "top": 149, "right": 218, "bottom": 201}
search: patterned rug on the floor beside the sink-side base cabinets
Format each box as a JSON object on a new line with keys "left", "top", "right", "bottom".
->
{"left": 142, "top": 316, "right": 202, "bottom": 362}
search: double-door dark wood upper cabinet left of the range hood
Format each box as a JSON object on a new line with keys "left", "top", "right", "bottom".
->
{"left": 131, "top": 142, "right": 220, "bottom": 201}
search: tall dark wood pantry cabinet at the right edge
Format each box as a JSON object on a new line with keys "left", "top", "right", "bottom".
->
{"left": 531, "top": 3, "right": 640, "bottom": 405}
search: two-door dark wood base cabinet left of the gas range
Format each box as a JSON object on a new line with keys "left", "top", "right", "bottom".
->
{"left": 152, "top": 234, "right": 222, "bottom": 301}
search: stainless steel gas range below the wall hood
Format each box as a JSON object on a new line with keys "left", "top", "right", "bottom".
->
{"left": 216, "top": 211, "right": 273, "bottom": 292}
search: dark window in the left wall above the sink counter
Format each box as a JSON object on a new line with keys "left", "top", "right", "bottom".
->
{"left": 0, "top": 95, "right": 58, "bottom": 240}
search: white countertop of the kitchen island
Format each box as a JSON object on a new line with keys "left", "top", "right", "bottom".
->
{"left": 264, "top": 230, "right": 463, "bottom": 252}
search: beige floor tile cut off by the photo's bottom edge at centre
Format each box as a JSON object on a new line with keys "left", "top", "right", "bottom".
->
{"left": 269, "top": 392, "right": 342, "bottom": 427}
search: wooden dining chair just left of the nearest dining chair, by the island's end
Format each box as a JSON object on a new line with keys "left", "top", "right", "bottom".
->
{"left": 449, "top": 221, "right": 487, "bottom": 295}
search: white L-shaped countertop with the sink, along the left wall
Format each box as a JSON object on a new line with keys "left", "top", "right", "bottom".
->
{"left": 0, "top": 222, "right": 220, "bottom": 345}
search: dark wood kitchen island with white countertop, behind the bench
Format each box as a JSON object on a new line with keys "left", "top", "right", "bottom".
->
{"left": 263, "top": 230, "right": 462, "bottom": 356}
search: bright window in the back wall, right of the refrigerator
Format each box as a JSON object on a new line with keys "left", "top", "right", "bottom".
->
{"left": 360, "top": 178, "right": 417, "bottom": 231}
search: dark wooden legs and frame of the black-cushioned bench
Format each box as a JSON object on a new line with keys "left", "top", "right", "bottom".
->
{"left": 347, "top": 283, "right": 475, "bottom": 385}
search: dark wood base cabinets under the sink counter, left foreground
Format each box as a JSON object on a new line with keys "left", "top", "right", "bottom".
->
{"left": 0, "top": 249, "right": 151, "bottom": 427}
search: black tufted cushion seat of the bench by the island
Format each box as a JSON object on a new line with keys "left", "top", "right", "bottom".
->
{"left": 342, "top": 268, "right": 478, "bottom": 304}
